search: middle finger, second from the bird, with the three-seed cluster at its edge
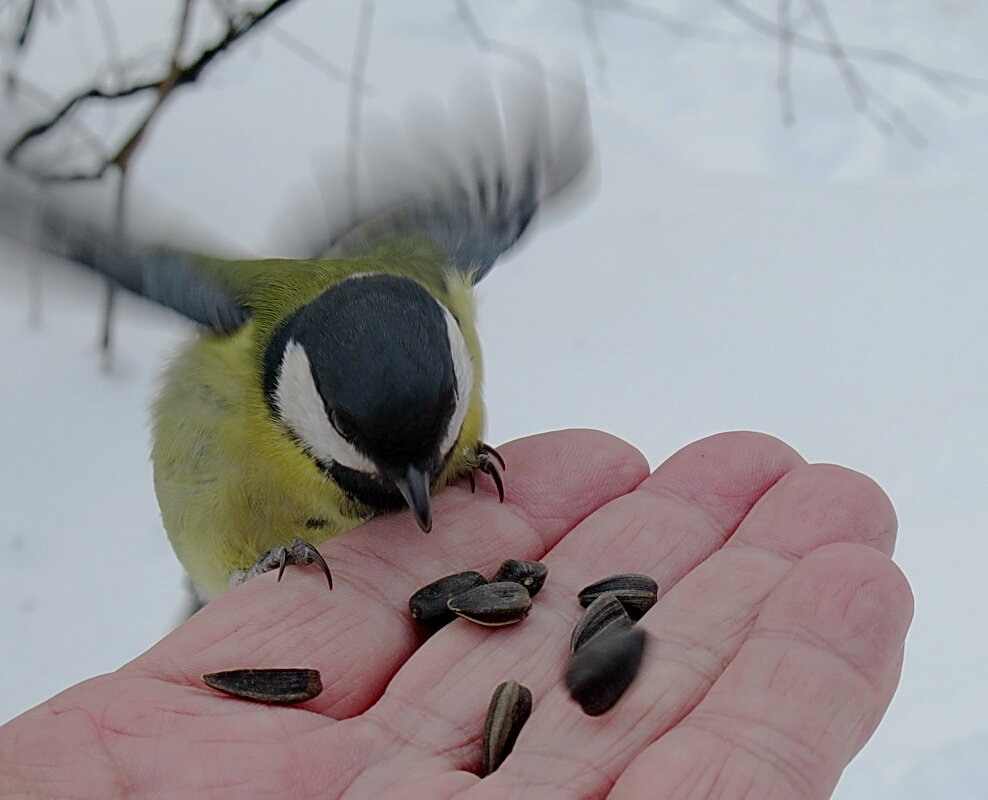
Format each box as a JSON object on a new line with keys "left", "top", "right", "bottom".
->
{"left": 316, "top": 433, "right": 803, "bottom": 788}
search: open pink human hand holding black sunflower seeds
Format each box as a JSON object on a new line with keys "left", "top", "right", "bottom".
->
{"left": 0, "top": 431, "right": 912, "bottom": 800}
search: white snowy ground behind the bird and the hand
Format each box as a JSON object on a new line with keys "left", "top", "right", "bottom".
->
{"left": 0, "top": 0, "right": 988, "bottom": 800}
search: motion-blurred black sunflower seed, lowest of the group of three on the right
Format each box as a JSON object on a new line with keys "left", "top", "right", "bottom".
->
{"left": 565, "top": 627, "right": 645, "bottom": 717}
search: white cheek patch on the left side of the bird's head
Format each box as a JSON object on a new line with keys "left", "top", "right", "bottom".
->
{"left": 275, "top": 340, "right": 377, "bottom": 475}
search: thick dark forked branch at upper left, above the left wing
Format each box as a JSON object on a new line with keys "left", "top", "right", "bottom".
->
{"left": 4, "top": 0, "right": 300, "bottom": 181}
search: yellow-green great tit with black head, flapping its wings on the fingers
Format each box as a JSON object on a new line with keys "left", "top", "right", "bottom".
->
{"left": 0, "top": 75, "right": 591, "bottom": 599}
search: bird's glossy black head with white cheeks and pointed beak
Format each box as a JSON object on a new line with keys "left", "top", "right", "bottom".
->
{"left": 264, "top": 273, "right": 473, "bottom": 530}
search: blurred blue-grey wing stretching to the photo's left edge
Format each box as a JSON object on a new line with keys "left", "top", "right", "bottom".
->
{"left": 0, "top": 172, "right": 250, "bottom": 332}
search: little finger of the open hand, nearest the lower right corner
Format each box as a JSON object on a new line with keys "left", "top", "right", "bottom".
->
{"left": 609, "top": 545, "right": 912, "bottom": 800}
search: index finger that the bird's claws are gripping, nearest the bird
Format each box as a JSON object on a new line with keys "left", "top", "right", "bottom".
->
{"left": 130, "top": 431, "right": 647, "bottom": 717}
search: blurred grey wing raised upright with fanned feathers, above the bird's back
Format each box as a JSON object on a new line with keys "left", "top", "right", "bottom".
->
{"left": 278, "top": 70, "right": 593, "bottom": 282}
